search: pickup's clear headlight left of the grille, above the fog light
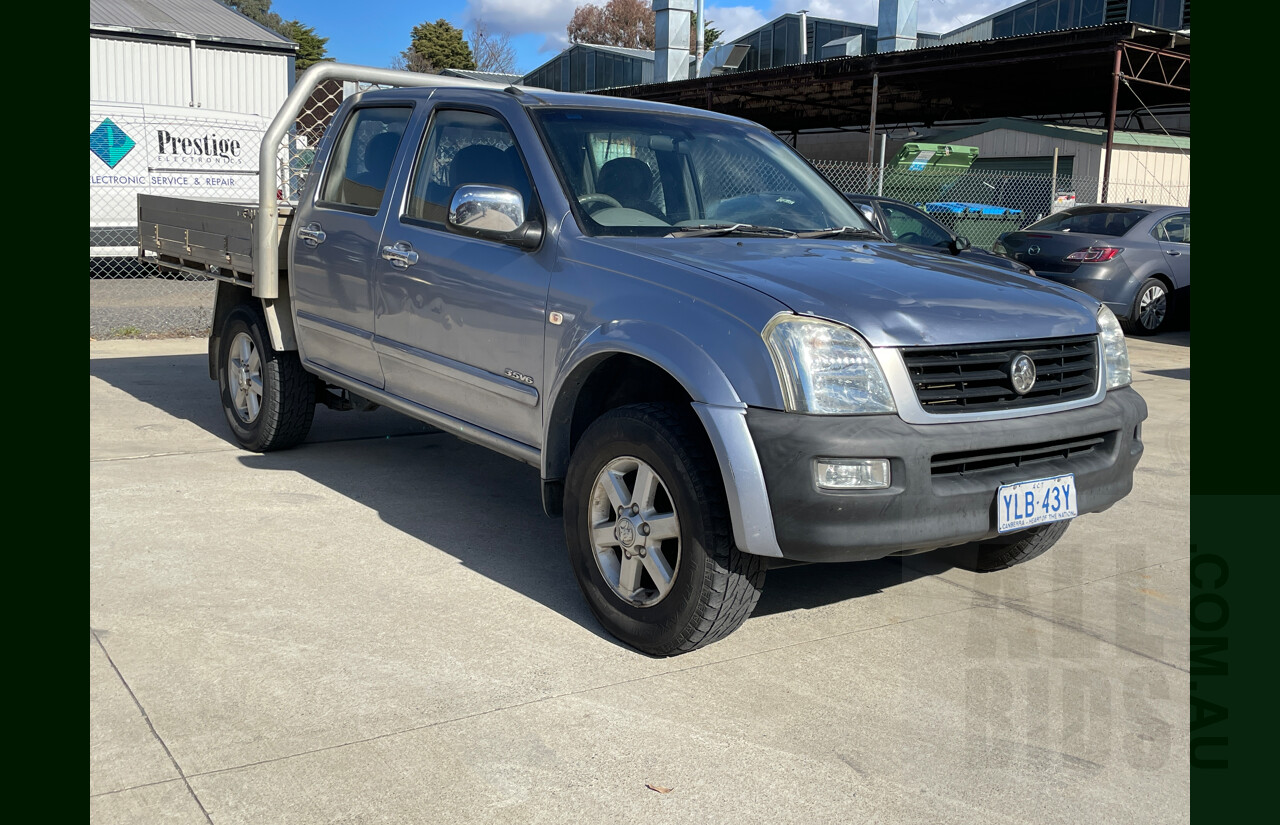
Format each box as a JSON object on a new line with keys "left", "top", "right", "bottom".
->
{"left": 764, "top": 315, "right": 896, "bottom": 416}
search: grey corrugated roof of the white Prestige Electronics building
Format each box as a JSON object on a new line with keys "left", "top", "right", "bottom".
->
{"left": 88, "top": 0, "right": 298, "bottom": 52}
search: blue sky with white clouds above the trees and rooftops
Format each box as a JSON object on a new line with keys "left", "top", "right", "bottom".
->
{"left": 271, "top": 0, "right": 1019, "bottom": 74}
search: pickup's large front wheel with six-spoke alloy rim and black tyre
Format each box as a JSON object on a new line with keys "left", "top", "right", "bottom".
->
{"left": 564, "top": 404, "right": 764, "bottom": 656}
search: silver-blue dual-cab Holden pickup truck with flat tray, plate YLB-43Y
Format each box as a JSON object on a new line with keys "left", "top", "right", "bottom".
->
{"left": 138, "top": 64, "right": 1147, "bottom": 655}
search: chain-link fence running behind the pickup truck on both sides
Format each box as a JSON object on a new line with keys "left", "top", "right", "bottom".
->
{"left": 90, "top": 94, "right": 1190, "bottom": 339}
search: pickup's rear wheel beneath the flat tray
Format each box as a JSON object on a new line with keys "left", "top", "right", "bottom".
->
{"left": 218, "top": 306, "right": 316, "bottom": 453}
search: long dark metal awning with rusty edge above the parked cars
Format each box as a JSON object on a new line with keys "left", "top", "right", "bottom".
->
{"left": 595, "top": 23, "right": 1190, "bottom": 133}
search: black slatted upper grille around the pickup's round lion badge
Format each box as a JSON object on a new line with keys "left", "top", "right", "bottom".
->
{"left": 902, "top": 335, "right": 1098, "bottom": 414}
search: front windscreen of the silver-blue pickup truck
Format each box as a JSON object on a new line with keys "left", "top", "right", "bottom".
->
{"left": 532, "top": 107, "right": 870, "bottom": 237}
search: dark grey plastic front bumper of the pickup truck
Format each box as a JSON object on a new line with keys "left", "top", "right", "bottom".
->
{"left": 746, "top": 388, "right": 1147, "bottom": 562}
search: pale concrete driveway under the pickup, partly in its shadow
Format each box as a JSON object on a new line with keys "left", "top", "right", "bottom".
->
{"left": 90, "top": 333, "right": 1190, "bottom": 825}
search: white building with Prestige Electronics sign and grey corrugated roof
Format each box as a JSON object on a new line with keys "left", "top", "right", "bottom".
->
{"left": 88, "top": 0, "right": 298, "bottom": 259}
